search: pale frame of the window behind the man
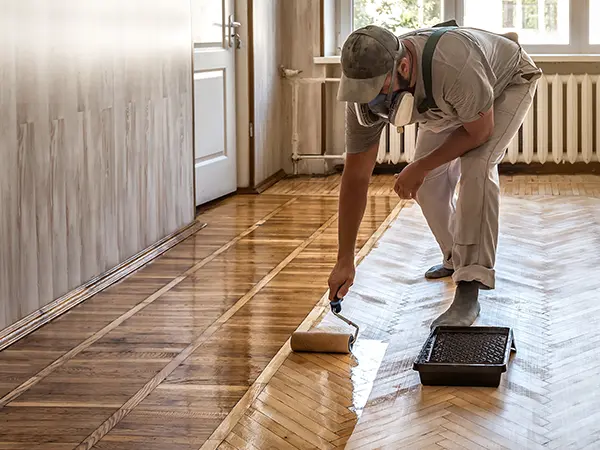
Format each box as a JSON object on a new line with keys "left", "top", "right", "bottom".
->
{"left": 335, "top": 0, "right": 600, "bottom": 56}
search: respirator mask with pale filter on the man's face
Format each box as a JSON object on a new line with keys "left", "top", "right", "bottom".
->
{"left": 368, "top": 58, "right": 415, "bottom": 128}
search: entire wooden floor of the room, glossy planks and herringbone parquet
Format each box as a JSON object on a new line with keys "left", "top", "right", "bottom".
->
{"left": 0, "top": 175, "right": 600, "bottom": 450}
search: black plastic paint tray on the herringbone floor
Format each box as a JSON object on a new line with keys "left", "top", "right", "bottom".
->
{"left": 413, "top": 326, "right": 516, "bottom": 387}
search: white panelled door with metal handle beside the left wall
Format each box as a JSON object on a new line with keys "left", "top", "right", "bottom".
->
{"left": 192, "top": 0, "right": 239, "bottom": 206}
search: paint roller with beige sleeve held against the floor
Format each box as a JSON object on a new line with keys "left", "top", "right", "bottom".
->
{"left": 290, "top": 298, "right": 358, "bottom": 353}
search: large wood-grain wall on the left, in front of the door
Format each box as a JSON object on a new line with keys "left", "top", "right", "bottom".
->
{"left": 0, "top": 0, "right": 193, "bottom": 329}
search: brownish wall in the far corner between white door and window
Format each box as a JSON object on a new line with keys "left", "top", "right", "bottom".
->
{"left": 251, "top": 0, "right": 324, "bottom": 185}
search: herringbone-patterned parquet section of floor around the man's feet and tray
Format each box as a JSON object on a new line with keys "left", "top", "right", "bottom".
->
{"left": 203, "top": 176, "right": 600, "bottom": 449}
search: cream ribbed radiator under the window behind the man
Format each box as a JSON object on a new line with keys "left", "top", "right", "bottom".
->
{"left": 377, "top": 74, "right": 600, "bottom": 164}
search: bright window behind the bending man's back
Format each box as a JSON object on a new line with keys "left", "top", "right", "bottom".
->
{"left": 332, "top": 0, "right": 600, "bottom": 54}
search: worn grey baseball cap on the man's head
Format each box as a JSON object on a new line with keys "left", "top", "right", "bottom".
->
{"left": 337, "top": 25, "right": 401, "bottom": 103}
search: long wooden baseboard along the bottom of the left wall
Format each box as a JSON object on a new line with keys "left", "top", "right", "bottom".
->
{"left": 0, "top": 221, "right": 206, "bottom": 351}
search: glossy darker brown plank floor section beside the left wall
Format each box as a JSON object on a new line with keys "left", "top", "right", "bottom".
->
{"left": 0, "top": 191, "right": 398, "bottom": 450}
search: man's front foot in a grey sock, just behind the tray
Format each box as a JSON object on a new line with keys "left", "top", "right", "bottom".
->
{"left": 431, "top": 281, "right": 481, "bottom": 329}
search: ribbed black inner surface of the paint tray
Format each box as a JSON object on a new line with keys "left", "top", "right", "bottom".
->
{"left": 418, "top": 331, "right": 508, "bottom": 364}
